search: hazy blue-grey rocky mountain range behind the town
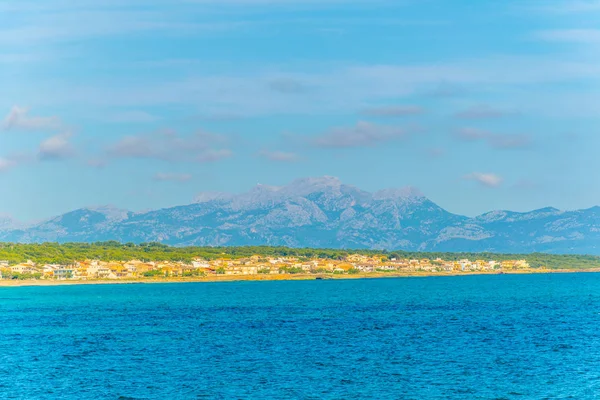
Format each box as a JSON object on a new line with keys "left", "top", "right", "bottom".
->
{"left": 0, "top": 176, "right": 600, "bottom": 255}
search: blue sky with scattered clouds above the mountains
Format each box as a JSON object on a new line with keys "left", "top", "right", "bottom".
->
{"left": 0, "top": 0, "right": 600, "bottom": 221}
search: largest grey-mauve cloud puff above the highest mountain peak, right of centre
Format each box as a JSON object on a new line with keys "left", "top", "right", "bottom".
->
{"left": 311, "top": 121, "right": 411, "bottom": 149}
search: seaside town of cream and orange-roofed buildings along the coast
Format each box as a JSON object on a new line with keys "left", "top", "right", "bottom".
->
{"left": 0, "top": 254, "right": 530, "bottom": 281}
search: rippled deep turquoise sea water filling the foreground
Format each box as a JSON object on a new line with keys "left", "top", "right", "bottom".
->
{"left": 0, "top": 274, "right": 600, "bottom": 399}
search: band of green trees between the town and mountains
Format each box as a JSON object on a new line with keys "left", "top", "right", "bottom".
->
{"left": 0, "top": 241, "right": 600, "bottom": 270}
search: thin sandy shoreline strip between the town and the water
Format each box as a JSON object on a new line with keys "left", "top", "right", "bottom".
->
{"left": 0, "top": 269, "right": 600, "bottom": 288}
